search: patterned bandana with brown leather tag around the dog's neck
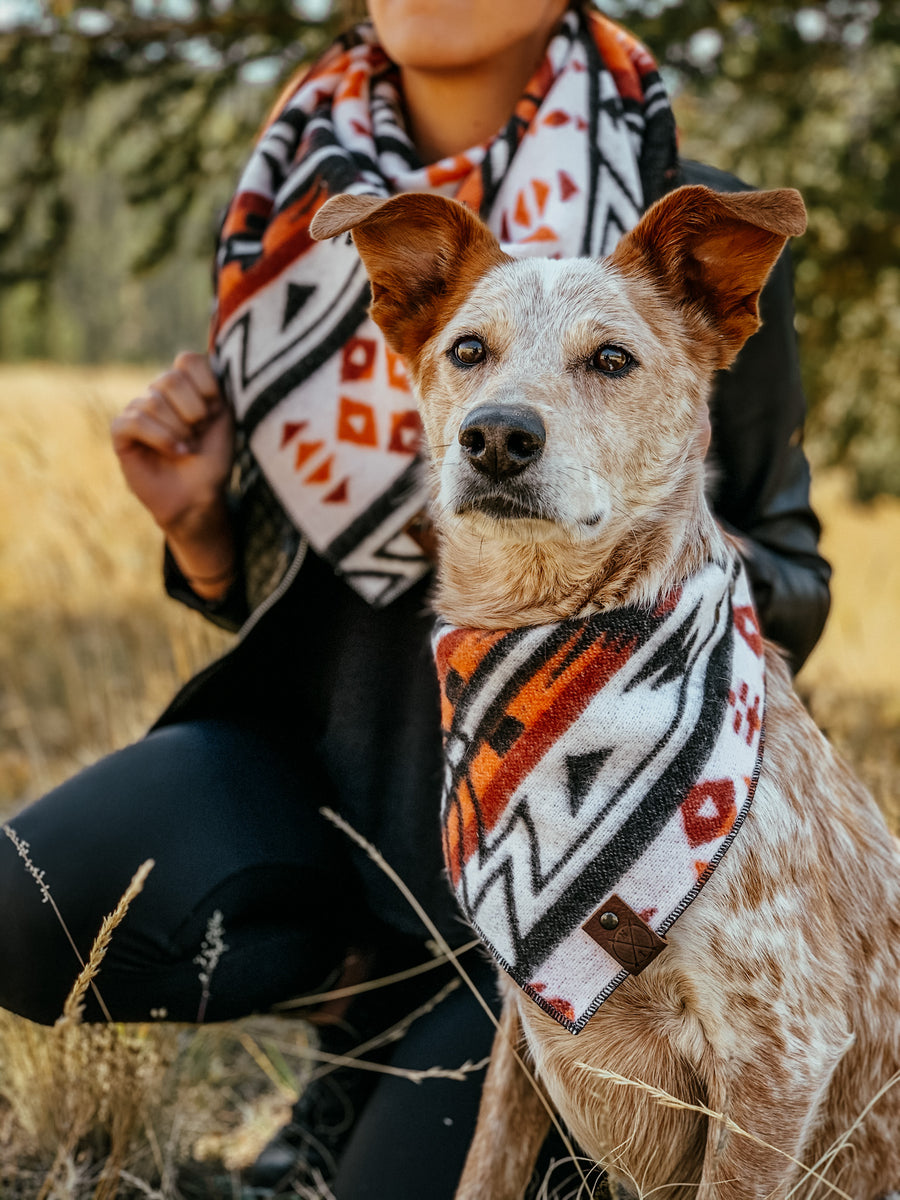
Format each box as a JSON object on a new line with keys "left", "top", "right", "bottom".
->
{"left": 434, "top": 562, "right": 766, "bottom": 1033}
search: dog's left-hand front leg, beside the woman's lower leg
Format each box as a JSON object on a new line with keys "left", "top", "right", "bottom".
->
{"left": 456, "top": 996, "right": 550, "bottom": 1200}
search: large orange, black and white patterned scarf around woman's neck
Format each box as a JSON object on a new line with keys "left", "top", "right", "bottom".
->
{"left": 211, "top": 10, "right": 676, "bottom": 605}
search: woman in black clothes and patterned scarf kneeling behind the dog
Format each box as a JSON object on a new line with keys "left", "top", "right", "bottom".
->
{"left": 0, "top": 0, "right": 829, "bottom": 1200}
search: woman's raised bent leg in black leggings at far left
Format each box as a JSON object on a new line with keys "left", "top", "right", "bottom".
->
{"left": 0, "top": 721, "right": 365, "bottom": 1024}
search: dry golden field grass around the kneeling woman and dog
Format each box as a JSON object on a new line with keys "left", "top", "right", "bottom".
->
{"left": 0, "top": 365, "right": 900, "bottom": 1200}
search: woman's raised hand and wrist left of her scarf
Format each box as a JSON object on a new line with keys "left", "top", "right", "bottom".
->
{"left": 112, "top": 354, "right": 235, "bottom": 600}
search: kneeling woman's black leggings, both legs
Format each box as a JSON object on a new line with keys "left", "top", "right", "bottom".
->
{"left": 0, "top": 721, "right": 578, "bottom": 1200}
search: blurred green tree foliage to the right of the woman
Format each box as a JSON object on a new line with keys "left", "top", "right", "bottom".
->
{"left": 604, "top": 0, "right": 900, "bottom": 498}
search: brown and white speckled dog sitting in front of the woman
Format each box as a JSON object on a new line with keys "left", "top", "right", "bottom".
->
{"left": 312, "top": 187, "right": 900, "bottom": 1200}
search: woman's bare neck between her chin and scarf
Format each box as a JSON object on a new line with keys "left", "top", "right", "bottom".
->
{"left": 400, "top": 22, "right": 564, "bottom": 163}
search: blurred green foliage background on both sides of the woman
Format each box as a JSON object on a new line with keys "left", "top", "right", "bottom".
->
{"left": 0, "top": 0, "right": 900, "bottom": 497}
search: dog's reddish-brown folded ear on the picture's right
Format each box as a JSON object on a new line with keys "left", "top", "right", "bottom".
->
{"left": 612, "top": 186, "right": 806, "bottom": 367}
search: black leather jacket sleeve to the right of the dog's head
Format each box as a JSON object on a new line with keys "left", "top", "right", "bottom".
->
{"left": 710, "top": 251, "right": 832, "bottom": 671}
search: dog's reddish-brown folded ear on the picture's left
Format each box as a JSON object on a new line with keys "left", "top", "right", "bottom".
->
{"left": 310, "top": 192, "right": 509, "bottom": 359}
